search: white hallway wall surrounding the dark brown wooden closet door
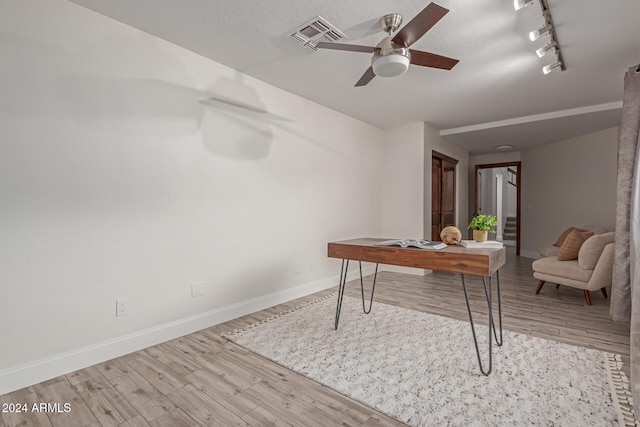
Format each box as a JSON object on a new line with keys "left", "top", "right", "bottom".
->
{"left": 423, "top": 123, "right": 469, "bottom": 242}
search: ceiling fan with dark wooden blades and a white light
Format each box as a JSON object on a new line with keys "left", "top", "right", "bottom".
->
{"left": 316, "top": 2, "right": 458, "bottom": 87}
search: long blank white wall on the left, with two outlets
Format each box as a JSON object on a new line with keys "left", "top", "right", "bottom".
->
{"left": 0, "top": 0, "right": 384, "bottom": 394}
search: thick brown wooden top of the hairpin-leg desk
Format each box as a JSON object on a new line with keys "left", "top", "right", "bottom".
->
{"left": 328, "top": 237, "right": 507, "bottom": 276}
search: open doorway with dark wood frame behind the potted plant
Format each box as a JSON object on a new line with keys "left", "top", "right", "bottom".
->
{"left": 474, "top": 162, "right": 522, "bottom": 255}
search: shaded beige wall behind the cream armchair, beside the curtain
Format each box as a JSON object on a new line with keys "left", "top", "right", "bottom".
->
{"left": 521, "top": 127, "right": 618, "bottom": 258}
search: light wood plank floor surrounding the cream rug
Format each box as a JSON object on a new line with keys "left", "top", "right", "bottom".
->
{"left": 0, "top": 249, "right": 629, "bottom": 427}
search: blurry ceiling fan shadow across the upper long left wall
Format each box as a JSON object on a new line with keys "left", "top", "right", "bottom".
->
{"left": 0, "top": 29, "right": 348, "bottom": 164}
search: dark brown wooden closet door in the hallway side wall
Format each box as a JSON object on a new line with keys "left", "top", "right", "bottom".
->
{"left": 431, "top": 151, "right": 458, "bottom": 241}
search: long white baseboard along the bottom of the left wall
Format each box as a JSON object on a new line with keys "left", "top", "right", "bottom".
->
{"left": 0, "top": 267, "right": 374, "bottom": 395}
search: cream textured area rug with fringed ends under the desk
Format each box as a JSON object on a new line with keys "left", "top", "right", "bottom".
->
{"left": 223, "top": 295, "right": 634, "bottom": 427}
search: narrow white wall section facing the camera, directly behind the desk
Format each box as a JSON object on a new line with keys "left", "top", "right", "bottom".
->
{"left": 380, "top": 122, "right": 430, "bottom": 275}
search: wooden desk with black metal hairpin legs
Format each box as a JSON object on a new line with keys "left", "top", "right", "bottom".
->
{"left": 327, "top": 237, "right": 506, "bottom": 375}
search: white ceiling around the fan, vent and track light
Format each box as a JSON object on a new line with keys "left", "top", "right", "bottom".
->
{"left": 72, "top": 0, "right": 640, "bottom": 154}
